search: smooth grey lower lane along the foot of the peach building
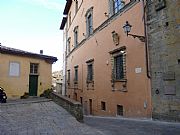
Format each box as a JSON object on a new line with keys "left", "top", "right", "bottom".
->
{"left": 84, "top": 116, "right": 180, "bottom": 135}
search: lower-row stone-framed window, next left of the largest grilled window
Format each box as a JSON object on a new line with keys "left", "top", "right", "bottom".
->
{"left": 86, "top": 59, "right": 94, "bottom": 83}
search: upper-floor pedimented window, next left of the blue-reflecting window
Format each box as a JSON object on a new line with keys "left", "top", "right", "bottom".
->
{"left": 85, "top": 7, "right": 93, "bottom": 36}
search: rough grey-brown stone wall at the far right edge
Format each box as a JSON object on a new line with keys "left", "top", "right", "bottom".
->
{"left": 147, "top": 0, "right": 180, "bottom": 121}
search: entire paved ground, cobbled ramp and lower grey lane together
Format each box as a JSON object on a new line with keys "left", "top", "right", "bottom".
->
{"left": 0, "top": 98, "right": 180, "bottom": 135}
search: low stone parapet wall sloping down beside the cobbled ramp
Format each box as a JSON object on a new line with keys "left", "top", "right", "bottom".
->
{"left": 50, "top": 93, "right": 83, "bottom": 122}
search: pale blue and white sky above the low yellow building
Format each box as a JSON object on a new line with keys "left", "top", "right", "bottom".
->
{"left": 0, "top": 0, "right": 66, "bottom": 71}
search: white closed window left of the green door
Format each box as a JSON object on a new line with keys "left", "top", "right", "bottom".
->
{"left": 9, "top": 62, "right": 20, "bottom": 77}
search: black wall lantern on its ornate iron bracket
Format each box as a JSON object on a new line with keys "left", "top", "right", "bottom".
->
{"left": 123, "top": 21, "right": 146, "bottom": 42}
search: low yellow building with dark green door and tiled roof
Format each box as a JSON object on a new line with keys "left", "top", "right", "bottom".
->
{"left": 0, "top": 46, "right": 57, "bottom": 99}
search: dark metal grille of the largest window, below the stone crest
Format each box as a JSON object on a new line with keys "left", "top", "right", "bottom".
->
{"left": 114, "top": 55, "right": 124, "bottom": 80}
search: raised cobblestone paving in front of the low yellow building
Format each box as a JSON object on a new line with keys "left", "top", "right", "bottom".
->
{"left": 0, "top": 99, "right": 104, "bottom": 135}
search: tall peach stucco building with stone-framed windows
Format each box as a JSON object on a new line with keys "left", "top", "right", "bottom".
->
{"left": 60, "top": 0, "right": 151, "bottom": 117}
